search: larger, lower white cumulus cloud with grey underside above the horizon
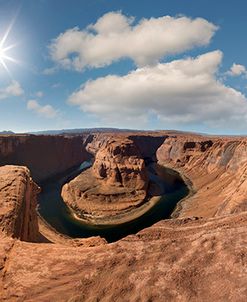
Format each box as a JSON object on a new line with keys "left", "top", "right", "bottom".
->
{"left": 68, "top": 51, "right": 247, "bottom": 128}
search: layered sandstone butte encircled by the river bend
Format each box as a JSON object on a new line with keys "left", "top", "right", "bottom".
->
{"left": 62, "top": 136, "right": 148, "bottom": 223}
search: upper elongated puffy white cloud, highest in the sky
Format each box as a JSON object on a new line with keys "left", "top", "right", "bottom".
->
{"left": 47, "top": 12, "right": 217, "bottom": 73}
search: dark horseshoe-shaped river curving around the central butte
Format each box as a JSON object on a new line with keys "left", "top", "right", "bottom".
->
{"left": 38, "top": 162, "right": 189, "bottom": 242}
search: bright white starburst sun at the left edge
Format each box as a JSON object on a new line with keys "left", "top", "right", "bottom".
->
{"left": 0, "top": 23, "right": 18, "bottom": 73}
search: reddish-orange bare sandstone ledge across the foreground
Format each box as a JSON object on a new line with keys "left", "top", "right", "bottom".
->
{"left": 0, "top": 213, "right": 247, "bottom": 302}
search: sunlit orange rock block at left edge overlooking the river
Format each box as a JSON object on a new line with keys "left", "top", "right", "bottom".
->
{"left": 0, "top": 166, "right": 39, "bottom": 241}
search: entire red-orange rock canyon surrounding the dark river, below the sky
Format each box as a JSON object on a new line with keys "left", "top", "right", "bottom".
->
{"left": 0, "top": 131, "right": 247, "bottom": 301}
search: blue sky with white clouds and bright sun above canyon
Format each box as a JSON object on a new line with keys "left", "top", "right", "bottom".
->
{"left": 0, "top": 0, "right": 247, "bottom": 134}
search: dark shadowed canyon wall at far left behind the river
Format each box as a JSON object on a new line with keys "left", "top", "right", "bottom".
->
{"left": 0, "top": 135, "right": 91, "bottom": 182}
